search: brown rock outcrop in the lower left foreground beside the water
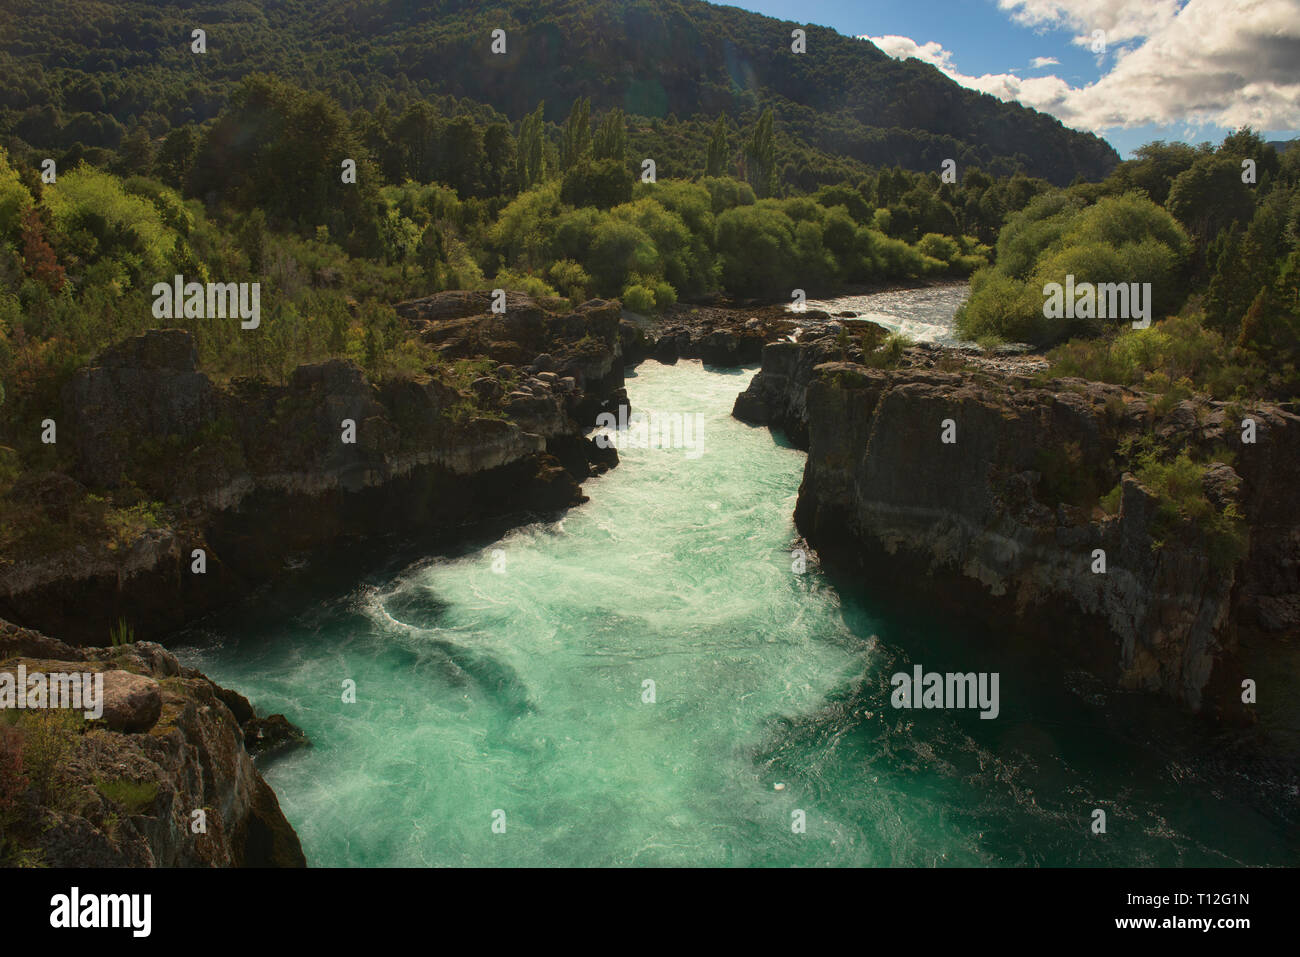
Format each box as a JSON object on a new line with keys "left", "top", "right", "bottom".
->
{"left": 0, "top": 622, "right": 306, "bottom": 867}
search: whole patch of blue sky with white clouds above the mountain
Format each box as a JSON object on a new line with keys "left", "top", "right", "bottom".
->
{"left": 712, "top": 0, "right": 1300, "bottom": 156}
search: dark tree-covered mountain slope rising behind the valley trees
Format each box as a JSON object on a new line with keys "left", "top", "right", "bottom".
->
{"left": 0, "top": 0, "right": 1118, "bottom": 190}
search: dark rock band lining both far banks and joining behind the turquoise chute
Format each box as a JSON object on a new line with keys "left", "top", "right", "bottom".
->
{"left": 0, "top": 293, "right": 1300, "bottom": 716}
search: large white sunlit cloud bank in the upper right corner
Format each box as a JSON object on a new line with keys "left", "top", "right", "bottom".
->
{"left": 863, "top": 0, "right": 1300, "bottom": 131}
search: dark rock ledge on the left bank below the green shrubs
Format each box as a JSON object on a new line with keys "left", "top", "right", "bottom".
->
{"left": 0, "top": 293, "right": 627, "bottom": 645}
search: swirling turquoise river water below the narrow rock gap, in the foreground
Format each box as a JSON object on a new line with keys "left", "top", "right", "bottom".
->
{"left": 185, "top": 363, "right": 1296, "bottom": 866}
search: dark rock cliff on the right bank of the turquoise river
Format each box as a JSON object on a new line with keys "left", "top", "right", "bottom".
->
{"left": 735, "top": 339, "right": 1300, "bottom": 716}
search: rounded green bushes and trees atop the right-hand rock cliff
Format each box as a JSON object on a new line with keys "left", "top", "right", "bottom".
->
{"left": 957, "top": 129, "right": 1300, "bottom": 406}
